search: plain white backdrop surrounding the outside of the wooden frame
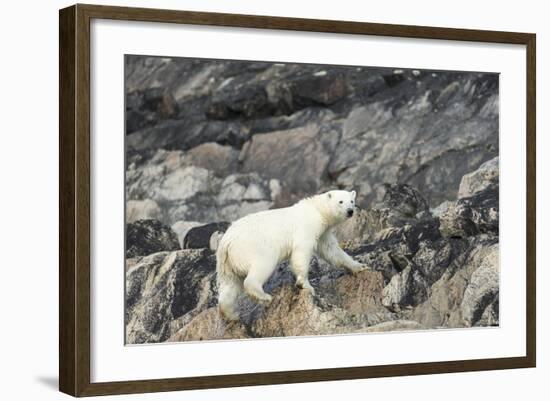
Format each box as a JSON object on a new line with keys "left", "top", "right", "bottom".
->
{"left": 0, "top": 0, "right": 550, "bottom": 400}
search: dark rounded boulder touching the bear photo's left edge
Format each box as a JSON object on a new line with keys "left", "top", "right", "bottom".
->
{"left": 126, "top": 220, "right": 179, "bottom": 258}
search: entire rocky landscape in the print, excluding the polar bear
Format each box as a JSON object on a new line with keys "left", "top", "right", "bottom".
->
{"left": 125, "top": 56, "right": 499, "bottom": 343}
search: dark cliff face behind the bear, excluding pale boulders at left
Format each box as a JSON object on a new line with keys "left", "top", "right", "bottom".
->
{"left": 126, "top": 56, "right": 499, "bottom": 225}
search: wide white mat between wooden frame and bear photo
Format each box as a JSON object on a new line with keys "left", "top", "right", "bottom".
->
{"left": 91, "top": 20, "right": 526, "bottom": 382}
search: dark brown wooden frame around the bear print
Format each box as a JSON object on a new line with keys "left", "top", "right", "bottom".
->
{"left": 59, "top": 5, "right": 536, "bottom": 396}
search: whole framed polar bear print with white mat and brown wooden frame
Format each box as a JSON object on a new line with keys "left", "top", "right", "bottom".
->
{"left": 59, "top": 5, "right": 536, "bottom": 396}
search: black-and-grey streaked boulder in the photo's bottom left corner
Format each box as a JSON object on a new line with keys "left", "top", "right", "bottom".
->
{"left": 125, "top": 249, "right": 217, "bottom": 344}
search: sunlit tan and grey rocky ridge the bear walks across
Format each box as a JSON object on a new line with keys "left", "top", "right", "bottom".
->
{"left": 126, "top": 159, "right": 499, "bottom": 343}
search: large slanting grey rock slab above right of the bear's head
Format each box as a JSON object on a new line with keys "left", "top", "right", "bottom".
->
{"left": 329, "top": 74, "right": 498, "bottom": 207}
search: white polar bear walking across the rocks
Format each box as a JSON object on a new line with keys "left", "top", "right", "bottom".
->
{"left": 216, "top": 191, "right": 366, "bottom": 320}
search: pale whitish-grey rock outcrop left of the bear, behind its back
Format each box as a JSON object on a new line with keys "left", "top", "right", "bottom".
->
{"left": 126, "top": 151, "right": 280, "bottom": 225}
